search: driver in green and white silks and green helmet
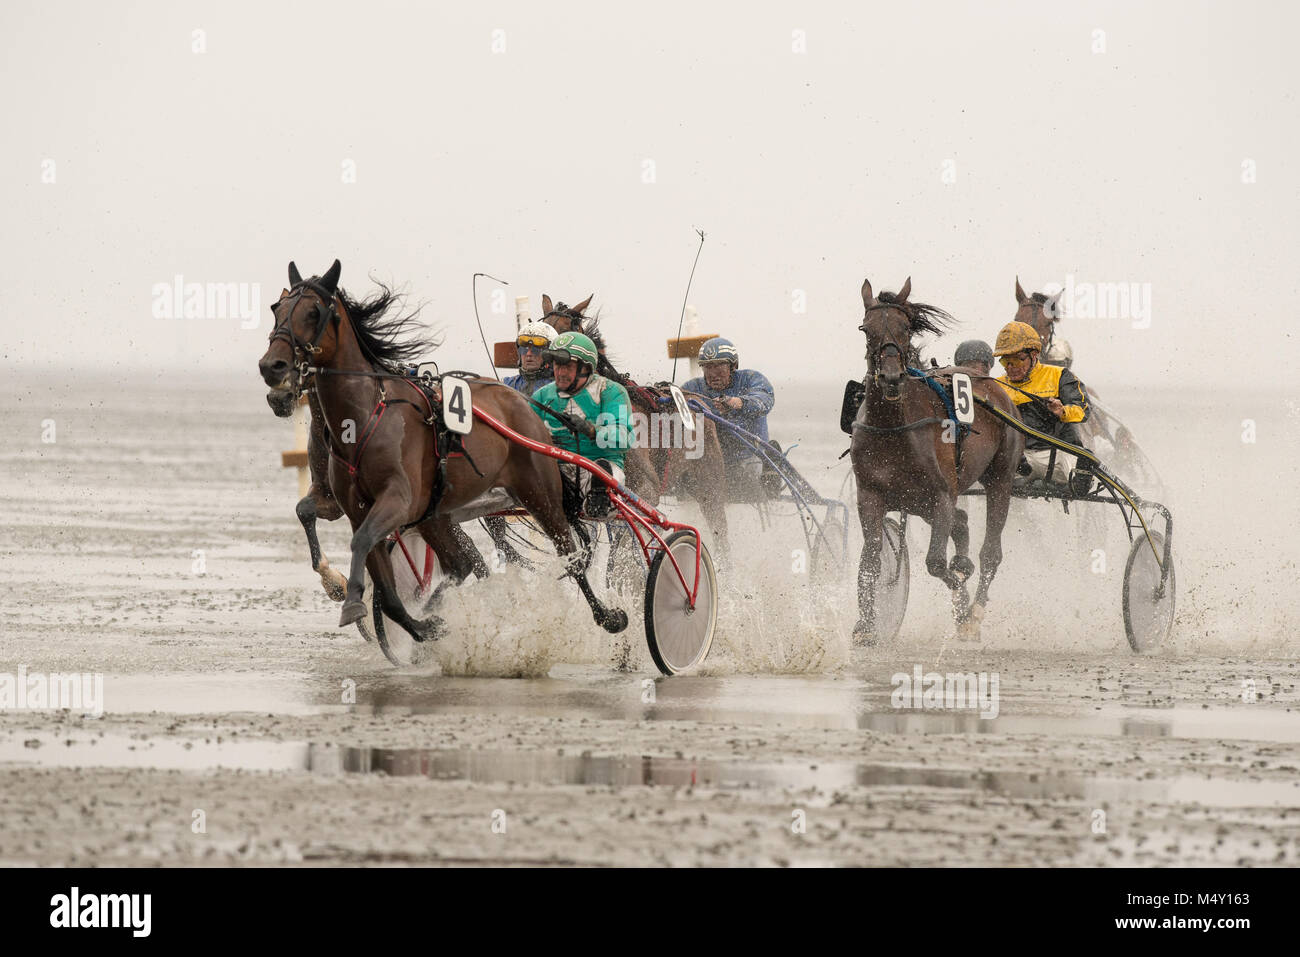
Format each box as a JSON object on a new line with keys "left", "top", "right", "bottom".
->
{"left": 533, "top": 332, "right": 633, "bottom": 518}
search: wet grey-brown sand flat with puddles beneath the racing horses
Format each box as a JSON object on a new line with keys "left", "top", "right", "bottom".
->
{"left": 0, "top": 380, "right": 1300, "bottom": 866}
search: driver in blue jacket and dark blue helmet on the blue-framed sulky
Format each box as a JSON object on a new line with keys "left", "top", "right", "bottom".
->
{"left": 681, "top": 337, "right": 776, "bottom": 480}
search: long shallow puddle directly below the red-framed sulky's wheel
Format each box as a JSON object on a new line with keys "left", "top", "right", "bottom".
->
{"left": 27, "top": 667, "right": 1300, "bottom": 742}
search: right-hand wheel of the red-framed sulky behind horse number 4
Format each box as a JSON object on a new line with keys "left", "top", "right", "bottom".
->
{"left": 645, "top": 529, "right": 718, "bottom": 675}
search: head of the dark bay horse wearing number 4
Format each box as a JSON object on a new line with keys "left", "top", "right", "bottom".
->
{"left": 257, "top": 259, "right": 342, "bottom": 419}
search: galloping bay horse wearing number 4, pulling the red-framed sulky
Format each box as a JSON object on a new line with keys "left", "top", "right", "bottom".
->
{"left": 257, "top": 260, "right": 628, "bottom": 641}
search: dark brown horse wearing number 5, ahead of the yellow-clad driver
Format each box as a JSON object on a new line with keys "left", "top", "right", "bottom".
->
{"left": 850, "top": 278, "right": 1024, "bottom": 645}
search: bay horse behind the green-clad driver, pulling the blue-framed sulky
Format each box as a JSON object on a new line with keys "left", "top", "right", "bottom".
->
{"left": 542, "top": 293, "right": 729, "bottom": 563}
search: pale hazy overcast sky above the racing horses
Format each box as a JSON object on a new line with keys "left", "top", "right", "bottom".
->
{"left": 0, "top": 0, "right": 1300, "bottom": 385}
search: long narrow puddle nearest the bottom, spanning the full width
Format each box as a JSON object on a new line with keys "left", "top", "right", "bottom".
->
{"left": 0, "top": 735, "right": 1300, "bottom": 807}
